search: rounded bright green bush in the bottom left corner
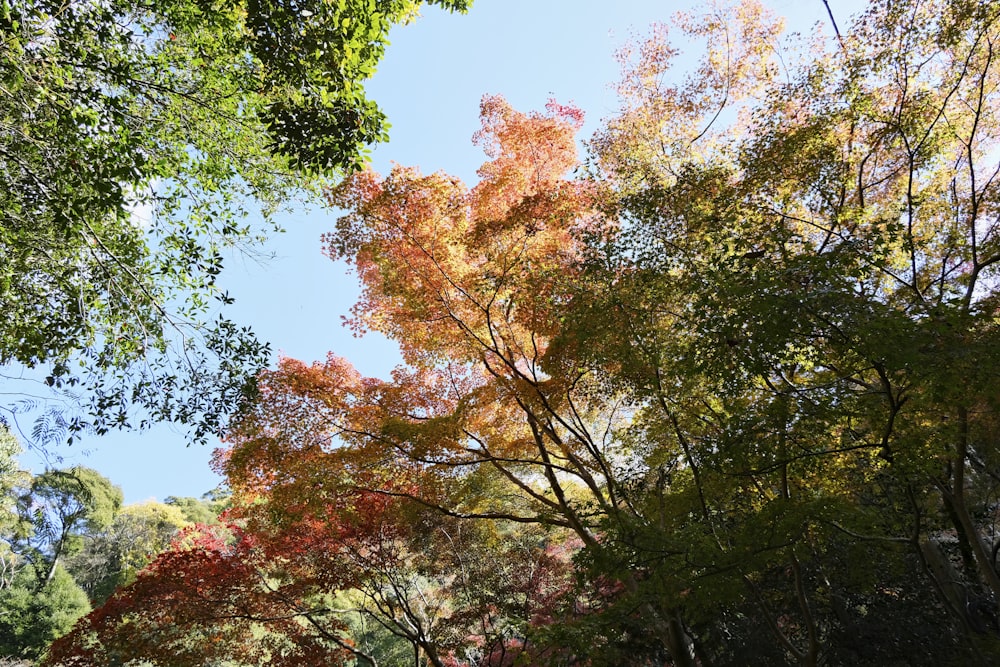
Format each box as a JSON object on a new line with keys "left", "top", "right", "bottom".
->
{"left": 0, "top": 566, "right": 90, "bottom": 659}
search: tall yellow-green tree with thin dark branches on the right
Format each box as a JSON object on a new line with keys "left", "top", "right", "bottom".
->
{"left": 587, "top": 2, "right": 997, "bottom": 664}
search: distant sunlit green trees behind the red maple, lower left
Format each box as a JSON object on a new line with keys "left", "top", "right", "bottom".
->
{"left": 0, "top": 429, "right": 222, "bottom": 666}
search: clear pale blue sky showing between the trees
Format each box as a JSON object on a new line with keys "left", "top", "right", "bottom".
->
{"left": 23, "top": 0, "right": 864, "bottom": 502}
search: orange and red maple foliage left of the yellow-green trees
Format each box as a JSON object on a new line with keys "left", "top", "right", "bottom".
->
{"left": 52, "top": 98, "right": 640, "bottom": 666}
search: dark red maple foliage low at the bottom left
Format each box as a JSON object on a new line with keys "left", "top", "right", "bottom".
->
{"left": 48, "top": 496, "right": 398, "bottom": 665}
